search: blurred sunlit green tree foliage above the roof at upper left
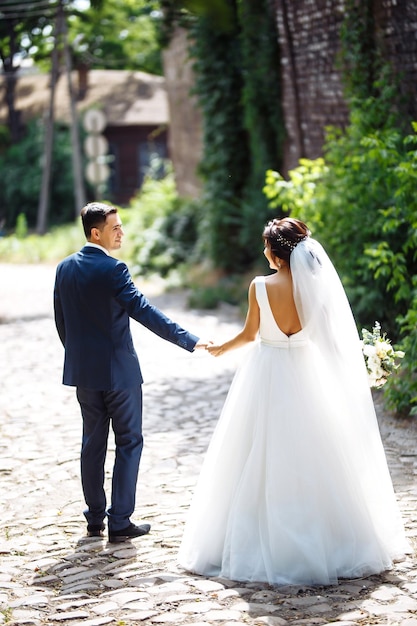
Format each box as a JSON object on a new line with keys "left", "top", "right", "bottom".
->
{"left": 0, "top": 0, "right": 162, "bottom": 143}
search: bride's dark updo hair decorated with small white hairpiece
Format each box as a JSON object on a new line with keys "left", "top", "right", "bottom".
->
{"left": 262, "top": 217, "right": 310, "bottom": 263}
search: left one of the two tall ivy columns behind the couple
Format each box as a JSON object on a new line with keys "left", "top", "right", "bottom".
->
{"left": 190, "top": 1, "right": 250, "bottom": 270}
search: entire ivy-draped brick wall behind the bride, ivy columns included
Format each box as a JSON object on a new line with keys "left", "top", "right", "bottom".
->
{"left": 158, "top": 0, "right": 417, "bottom": 272}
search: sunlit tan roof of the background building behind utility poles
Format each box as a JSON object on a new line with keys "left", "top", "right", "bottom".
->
{"left": 0, "top": 70, "right": 169, "bottom": 126}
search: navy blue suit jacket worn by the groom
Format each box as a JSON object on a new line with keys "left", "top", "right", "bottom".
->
{"left": 54, "top": 246, "right": 198, "bottom": 391}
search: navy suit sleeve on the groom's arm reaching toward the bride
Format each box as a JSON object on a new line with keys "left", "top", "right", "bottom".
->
{"left": 113, "top": 262, "right": 199, "bottom": 352}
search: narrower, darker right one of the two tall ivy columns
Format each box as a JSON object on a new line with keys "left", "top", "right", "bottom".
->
{"left": 239, "top": 0, "right": 285, "bottom": 255}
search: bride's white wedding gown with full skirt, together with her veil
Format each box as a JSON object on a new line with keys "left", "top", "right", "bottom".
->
{"left": 179, "top": 238, "right": 407, "bottom": 585}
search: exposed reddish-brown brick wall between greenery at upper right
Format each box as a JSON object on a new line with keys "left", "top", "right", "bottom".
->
{"left": 273, "top": 0, "right": 417, "bottom": 172}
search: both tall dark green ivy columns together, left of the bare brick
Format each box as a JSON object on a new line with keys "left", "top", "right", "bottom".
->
{"left": 163, "top": 0, "right": 284, "bottom": 272}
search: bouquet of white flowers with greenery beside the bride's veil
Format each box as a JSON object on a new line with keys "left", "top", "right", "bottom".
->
{"left": 361, "top": 322, "right": 404, "bottom": 388}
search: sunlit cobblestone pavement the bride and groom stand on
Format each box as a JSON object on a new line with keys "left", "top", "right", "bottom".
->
{"left": 0, "top": 265, "right": 417, "bottom": 626}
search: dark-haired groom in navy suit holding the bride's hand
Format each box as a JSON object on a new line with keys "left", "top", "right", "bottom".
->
{"left": 54, "top": 202, "right": 205, "bottom": 543}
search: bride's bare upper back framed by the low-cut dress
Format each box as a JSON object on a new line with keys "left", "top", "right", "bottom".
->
{"left": 265, "top": 267, "right": 301, "bottom": 336}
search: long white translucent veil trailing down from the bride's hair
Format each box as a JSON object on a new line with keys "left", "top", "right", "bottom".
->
{"left": 290, "top": 237, "right": 406, "bottom": 554}
